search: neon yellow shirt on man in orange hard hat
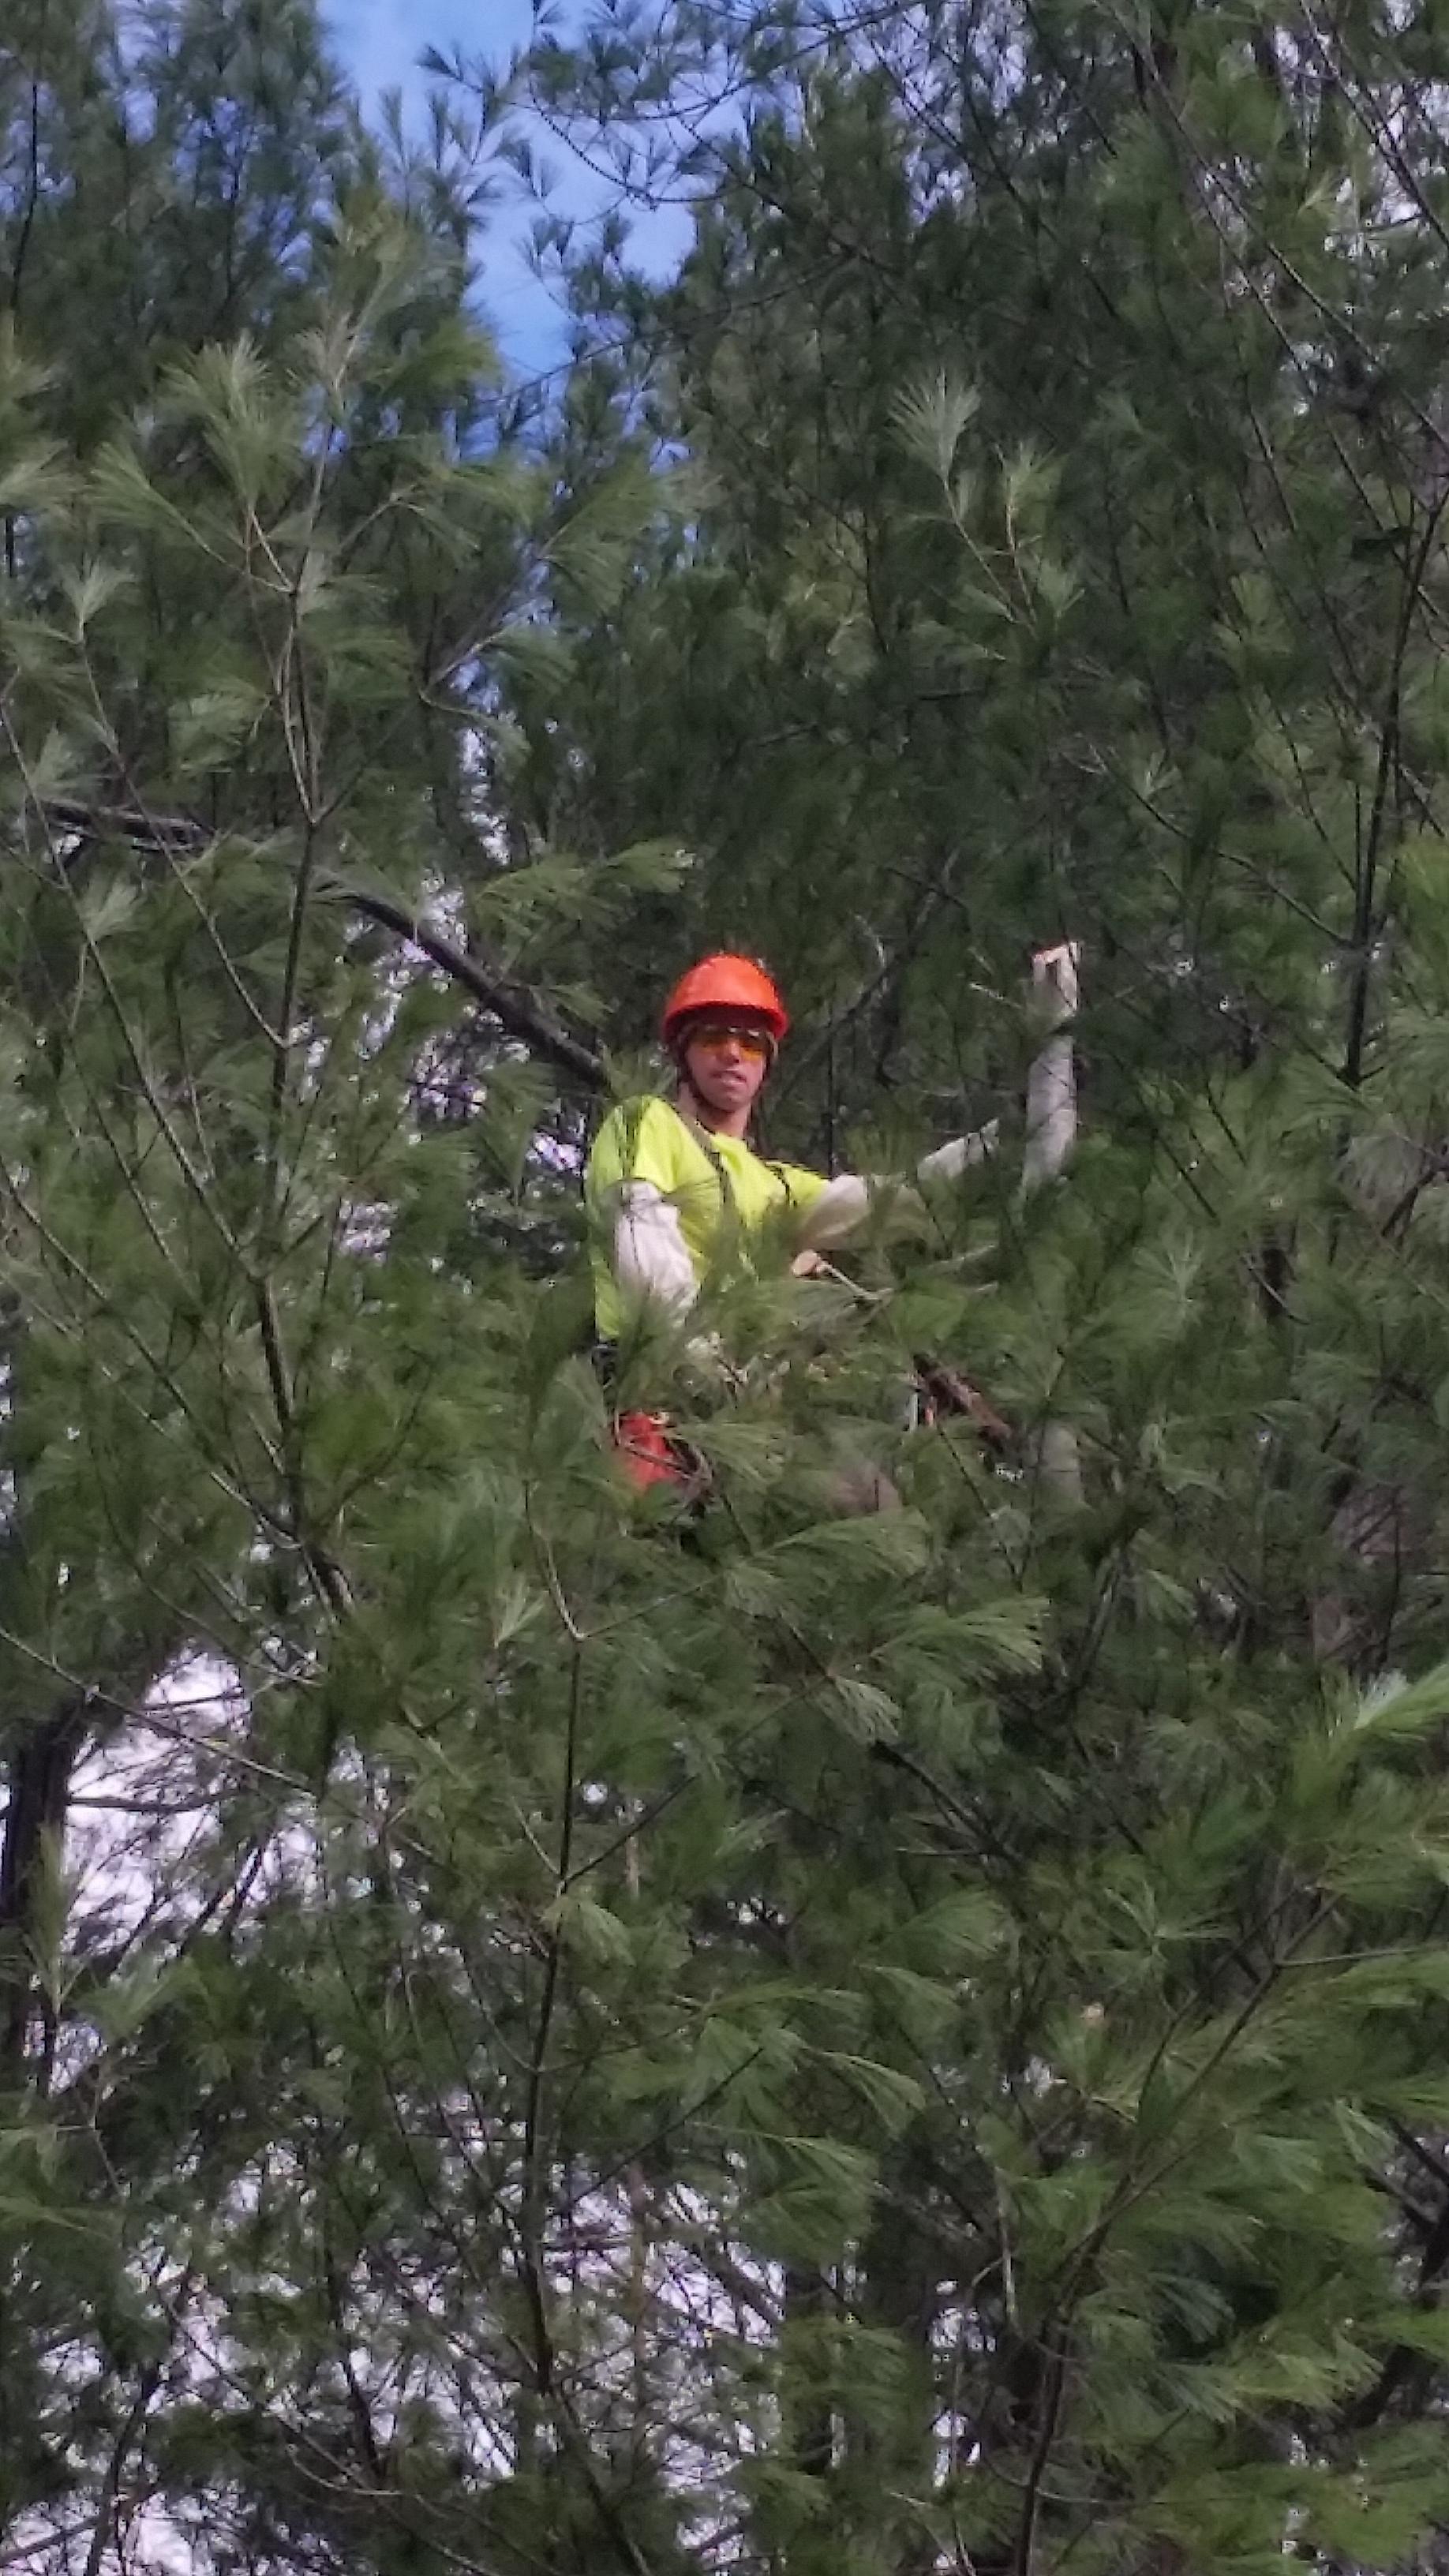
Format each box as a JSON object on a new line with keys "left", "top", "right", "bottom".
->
{"left": 582, "top": 1100, "right": 825, "bottom": 1342}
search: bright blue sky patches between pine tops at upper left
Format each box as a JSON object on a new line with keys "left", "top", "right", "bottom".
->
{"left": 322, "top": 0, "right": 686, "bottom": 373}
